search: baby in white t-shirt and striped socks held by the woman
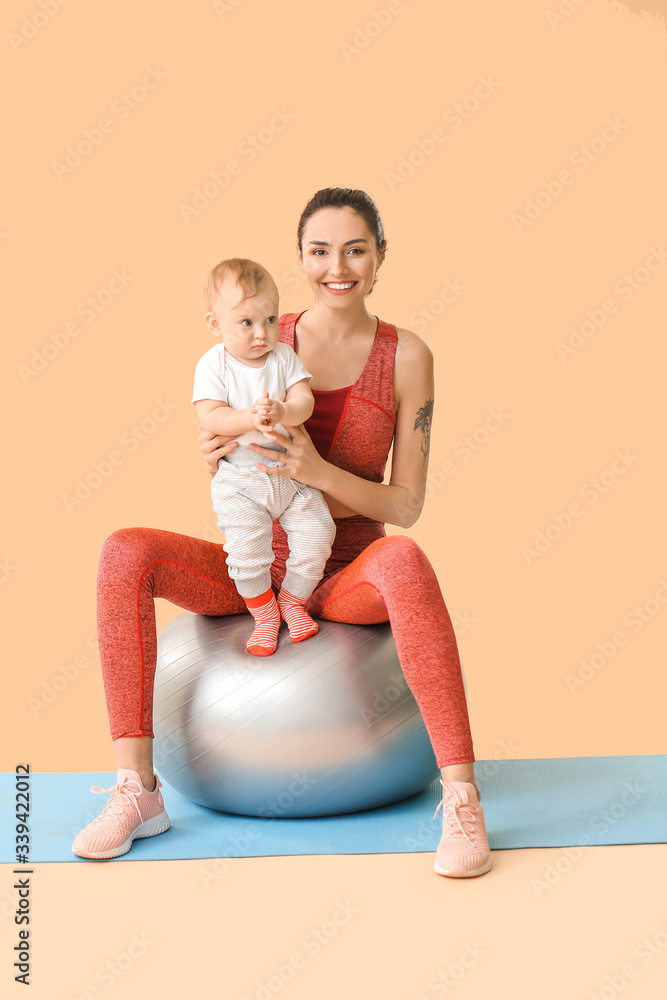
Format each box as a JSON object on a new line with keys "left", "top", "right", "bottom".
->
{"left": 192, "top": 257, "right": 336, "bottom": 656}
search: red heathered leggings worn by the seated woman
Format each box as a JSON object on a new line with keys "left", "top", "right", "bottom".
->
{"left": 98, "top": 521, "right": 474, "bottom": 767}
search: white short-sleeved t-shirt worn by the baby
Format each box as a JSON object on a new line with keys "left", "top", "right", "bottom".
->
{"left": 192, "top": 343, "right": 312, "bottom": 446}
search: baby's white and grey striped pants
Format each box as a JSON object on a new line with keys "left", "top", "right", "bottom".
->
{"left": 211, "top": 461, "right": 336, "bottom": 600}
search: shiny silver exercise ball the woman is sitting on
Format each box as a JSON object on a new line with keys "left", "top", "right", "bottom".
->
{"left": 154, "top": 611, "right": 439, "bottom": 817}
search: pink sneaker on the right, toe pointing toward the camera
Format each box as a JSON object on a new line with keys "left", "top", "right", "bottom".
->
{"left": 433, "top": 780, "right": 491, "bottom": 878}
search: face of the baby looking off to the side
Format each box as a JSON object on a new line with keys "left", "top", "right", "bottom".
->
{"left": 206, "top": 281, "right": 280, "bottom": 368}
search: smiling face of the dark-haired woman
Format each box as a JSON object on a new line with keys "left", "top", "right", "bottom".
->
{"left": 299, "top": 208, "right": 384, "bottom": 309}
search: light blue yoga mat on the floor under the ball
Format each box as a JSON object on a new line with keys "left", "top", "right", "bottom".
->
{"left": 0, "top": 755, "right": 667, "bottom": 864}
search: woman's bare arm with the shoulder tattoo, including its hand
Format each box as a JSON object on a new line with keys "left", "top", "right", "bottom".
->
{"left": 250, "top": 330, "right": 434, "bottom": 528}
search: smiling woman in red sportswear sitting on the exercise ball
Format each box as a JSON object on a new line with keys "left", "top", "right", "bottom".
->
{"left": 72, "top": 188, "right": 491, "bottom": 877}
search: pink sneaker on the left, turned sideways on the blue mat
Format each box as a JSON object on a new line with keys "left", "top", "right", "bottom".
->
{"left": 72, "top": 767, "right": 169, "bottom": 858}
